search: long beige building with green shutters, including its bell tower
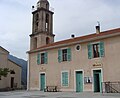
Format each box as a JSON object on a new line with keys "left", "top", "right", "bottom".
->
{"left": 28, "top": 0, "right": 120, "bottom": 92}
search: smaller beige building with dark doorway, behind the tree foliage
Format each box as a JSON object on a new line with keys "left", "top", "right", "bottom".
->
{"left": 0, "top": 46, "right": 22, "bottom": 89}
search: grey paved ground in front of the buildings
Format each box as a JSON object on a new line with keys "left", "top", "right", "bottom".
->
{"left": 0, "top": 91, "right": 120, "bottom": 98}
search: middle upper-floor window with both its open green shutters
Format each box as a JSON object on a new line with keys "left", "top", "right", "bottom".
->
{"left": 58, "top": 48, "right": 71, "bottom": 63}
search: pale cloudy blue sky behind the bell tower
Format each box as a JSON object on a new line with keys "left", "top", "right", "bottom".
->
{"left": 0, "top": 0, "right": 120, "bottom": 59}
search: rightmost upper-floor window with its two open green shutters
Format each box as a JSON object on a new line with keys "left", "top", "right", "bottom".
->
{"left": 88, "top": 42, "right": 105, "bottom": 59}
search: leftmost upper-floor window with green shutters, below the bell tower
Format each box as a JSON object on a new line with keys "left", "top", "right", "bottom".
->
{"left": 37, "top": 52, "right": 47, "bottom": 65}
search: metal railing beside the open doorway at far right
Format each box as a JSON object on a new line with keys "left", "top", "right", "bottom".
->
{"left": 102, "top": 81, "right": 120, "bottom": 93}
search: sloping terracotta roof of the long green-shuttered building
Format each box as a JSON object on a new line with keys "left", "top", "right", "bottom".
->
{"left": 29, "top": 28, "right": 120, "bottom": 52}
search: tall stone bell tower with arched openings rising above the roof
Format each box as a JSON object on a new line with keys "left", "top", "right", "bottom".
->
{"left": 30, "top": 0, "right": 55, "bottom": 50}
